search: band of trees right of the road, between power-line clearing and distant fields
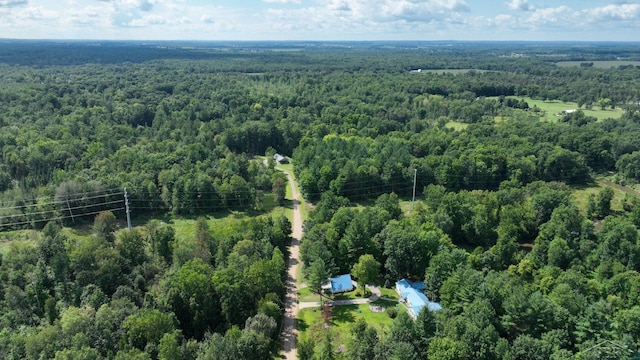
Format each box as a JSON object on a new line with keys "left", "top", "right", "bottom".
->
{"left": 293, "top": 109, "right": 640, "bottom": 200}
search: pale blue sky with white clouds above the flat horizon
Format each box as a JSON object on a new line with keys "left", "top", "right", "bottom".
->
{"left": 0, "top": 0, "right": 640, "bottom": 41}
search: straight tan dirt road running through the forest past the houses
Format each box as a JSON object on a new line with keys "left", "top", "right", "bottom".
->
{"left": 281, "top": 171, "right": 302, "bottom": 360}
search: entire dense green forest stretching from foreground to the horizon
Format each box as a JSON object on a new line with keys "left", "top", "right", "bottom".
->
{"left": 0, "top": 41, "right": 640, "bottom": 359}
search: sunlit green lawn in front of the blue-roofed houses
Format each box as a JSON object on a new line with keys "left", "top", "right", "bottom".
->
{"left": 297, "top": 300, "right": 406, "bottom": 347}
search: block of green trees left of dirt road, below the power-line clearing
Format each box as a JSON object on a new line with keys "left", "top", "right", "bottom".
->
{"left": 0, "top": 212, "right": 291, "bottom": 359}
